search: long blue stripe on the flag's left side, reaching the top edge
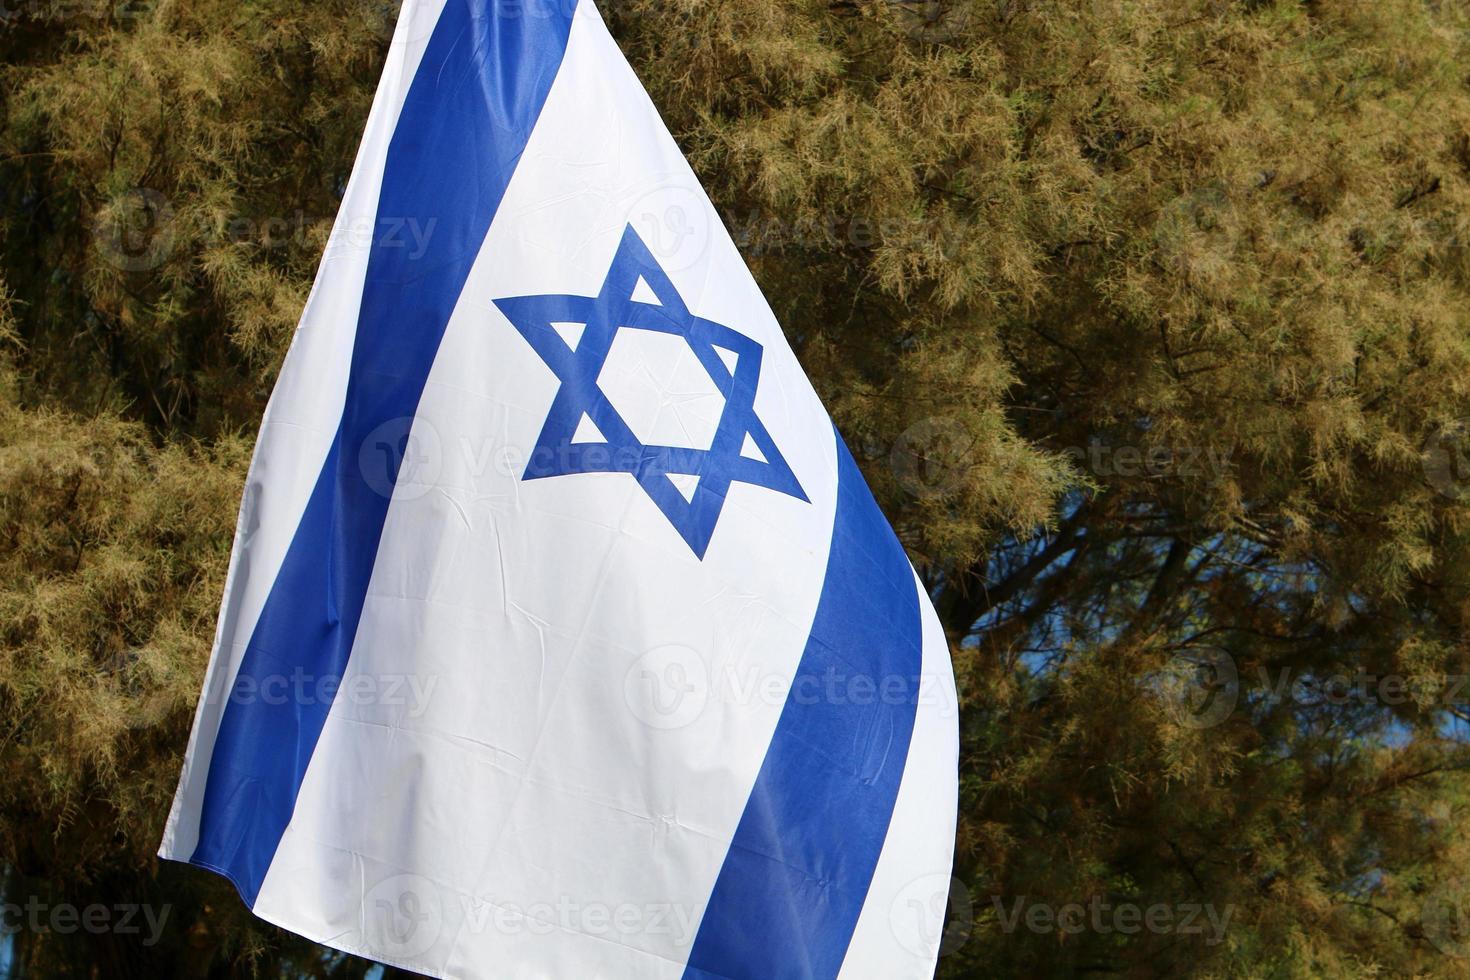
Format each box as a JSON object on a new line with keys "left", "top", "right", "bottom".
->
{"left": 190, "top": 0, "right": 575, "bottom": 905}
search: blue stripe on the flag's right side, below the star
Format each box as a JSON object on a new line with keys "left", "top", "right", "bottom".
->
{"left": 684, "top": 436, "right": 922, "bottom": 980}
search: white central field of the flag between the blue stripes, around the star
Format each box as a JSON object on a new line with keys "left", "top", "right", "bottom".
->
{"left": 256, "top": 3, "right": 836, "bottom": 977}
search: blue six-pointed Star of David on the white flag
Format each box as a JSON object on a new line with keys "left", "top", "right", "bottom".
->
{"left": 495, "top": 225, "right": 807, "bottom": 558}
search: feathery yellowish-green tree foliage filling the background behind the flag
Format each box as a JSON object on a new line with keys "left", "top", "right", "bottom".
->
{"left": 0, "top": 0, "right": 1470, "bottom": 977}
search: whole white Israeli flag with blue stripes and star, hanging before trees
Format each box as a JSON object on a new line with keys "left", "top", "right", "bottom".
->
{"left": 160, "top": 0, "right": 958, "bottom": 980}
